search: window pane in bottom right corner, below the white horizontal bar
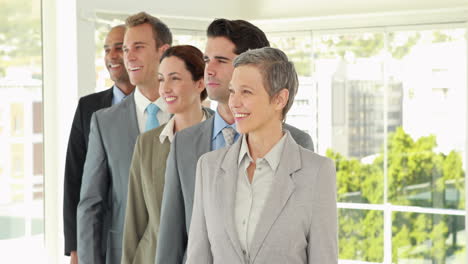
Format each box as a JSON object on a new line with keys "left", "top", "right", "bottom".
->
{"left": 392, "top": 213, "right": 467, "bottom": 264}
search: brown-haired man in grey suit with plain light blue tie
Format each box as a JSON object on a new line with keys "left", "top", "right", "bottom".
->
{"left": 77, "top": 12, "right": 172, "bottom": 264}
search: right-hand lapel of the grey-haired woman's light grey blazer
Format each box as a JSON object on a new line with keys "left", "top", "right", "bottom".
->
{"left": 249, "top": 132, "right": 301, "bottom": 262}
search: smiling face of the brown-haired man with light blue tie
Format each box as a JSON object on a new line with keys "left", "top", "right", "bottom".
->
{"left": 124, "top": 24, "right": 164, "bottom": 86}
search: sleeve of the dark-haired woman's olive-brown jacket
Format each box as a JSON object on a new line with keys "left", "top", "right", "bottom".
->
{"left": 122, "top": 137, "right": 148, "bottom": 264}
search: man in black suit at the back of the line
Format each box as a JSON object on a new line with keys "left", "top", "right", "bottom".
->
{"left": 63, "top": 25, "right": 135, "bottom": 264}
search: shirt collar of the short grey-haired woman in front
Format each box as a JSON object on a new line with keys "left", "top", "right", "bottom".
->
{"left": 237, "top": 132, "right": 287, "bottom": 171}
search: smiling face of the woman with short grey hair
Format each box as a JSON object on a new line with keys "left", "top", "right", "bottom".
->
{"left": 229, "top": 65, "right": 288, "bottom": 134}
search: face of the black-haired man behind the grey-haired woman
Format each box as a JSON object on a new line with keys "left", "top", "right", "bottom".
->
{"left": 203, "top": 37, "right": 237, "bottom": 104}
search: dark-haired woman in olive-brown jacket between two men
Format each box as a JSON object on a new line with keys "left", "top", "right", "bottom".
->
{"left": 122, "top": 45, "right": 213, "bottom": 264}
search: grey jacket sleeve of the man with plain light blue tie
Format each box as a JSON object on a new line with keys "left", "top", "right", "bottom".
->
{"left": 77, "top": 113, "right": 111, "bottom": 264}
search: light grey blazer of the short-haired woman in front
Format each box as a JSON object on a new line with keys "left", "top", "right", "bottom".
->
{"left": 187, "top": 133, "right": 338, "bottom": 264}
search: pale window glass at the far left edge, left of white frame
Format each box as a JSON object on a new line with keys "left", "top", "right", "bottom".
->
{"left": 0, "top": 0, "right": 45, "bottom": 263}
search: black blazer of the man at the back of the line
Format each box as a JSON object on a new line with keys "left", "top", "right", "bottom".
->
{"left": 63, "top": 87, "right": 113, "bottom": 256}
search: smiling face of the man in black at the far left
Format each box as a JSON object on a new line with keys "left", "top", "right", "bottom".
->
{"left": 104, "top": 26, "right": 128, "bottom": 83}
